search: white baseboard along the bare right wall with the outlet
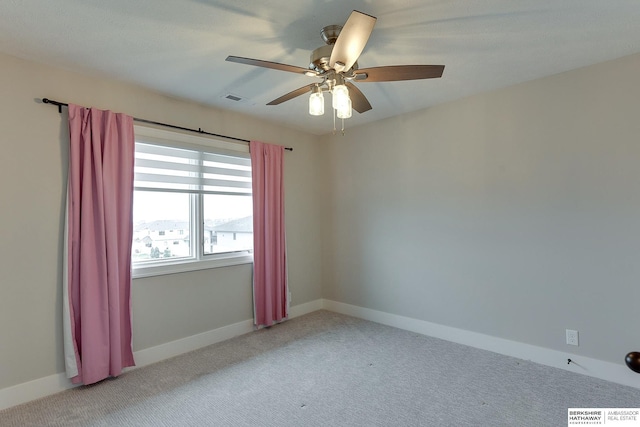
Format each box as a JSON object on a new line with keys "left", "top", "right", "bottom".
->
{"left": 322, "top": 299, "right": 640, "bottom": 388}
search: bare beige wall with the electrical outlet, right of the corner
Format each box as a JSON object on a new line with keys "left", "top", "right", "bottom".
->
{"left": 323, "top": 55, "right": 640, "bottom": 368}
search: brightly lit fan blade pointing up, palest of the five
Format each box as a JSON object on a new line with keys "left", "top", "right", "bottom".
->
{"left": 329, "top": 10, "right": 376, "bottom": 71}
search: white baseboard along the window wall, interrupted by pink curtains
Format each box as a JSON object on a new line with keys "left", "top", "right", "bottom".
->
{"left": 0, "top": 299, "right": 322, "bottom": 410}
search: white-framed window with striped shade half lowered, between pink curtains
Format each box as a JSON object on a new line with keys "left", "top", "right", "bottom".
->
{"left": 131, "top": 126, "right": 253, "bottom": 277}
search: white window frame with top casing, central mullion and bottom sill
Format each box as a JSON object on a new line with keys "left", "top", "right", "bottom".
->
{"left": 131, "top": 125, "right": 253, "bottom": 279}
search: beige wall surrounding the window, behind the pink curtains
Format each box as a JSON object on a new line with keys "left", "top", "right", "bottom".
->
{"left": 0, "top": 51, "right": 322, "bottom": 389}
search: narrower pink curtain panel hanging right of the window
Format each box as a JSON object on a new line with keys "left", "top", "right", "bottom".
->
{"left": 250, "top": 141, "right": 288, "bottom": 326}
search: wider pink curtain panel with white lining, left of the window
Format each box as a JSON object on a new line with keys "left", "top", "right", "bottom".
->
{"left": 64, "top": 104, "right": 135, "bottom": 384}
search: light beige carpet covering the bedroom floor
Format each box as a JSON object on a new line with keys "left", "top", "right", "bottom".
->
{"left": 0, "top": 311, "right": 640, "bottom": 427}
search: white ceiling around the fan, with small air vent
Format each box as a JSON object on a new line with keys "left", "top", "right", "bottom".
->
{"left": 0, "top": 0, "right": 640, "bottom": 134}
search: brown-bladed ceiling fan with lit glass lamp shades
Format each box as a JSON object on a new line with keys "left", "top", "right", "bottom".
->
{"left": 226, "top": 10, "right": 444, "bottom": 119}
